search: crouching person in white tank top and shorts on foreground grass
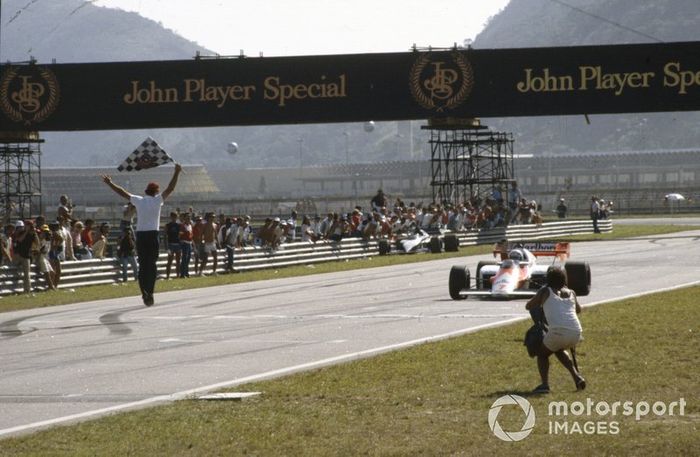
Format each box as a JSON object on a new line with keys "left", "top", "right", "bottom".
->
{"left": 525, "top": 267, "right": 586, "bottom": 393}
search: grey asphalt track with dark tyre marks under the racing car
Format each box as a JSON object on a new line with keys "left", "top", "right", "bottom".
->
{"left": 0, "top": 230, "right": 700, "bottom": 438}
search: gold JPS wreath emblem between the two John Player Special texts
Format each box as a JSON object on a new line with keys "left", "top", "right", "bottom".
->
{"left": 409, "top": 51, "right": 474, "bottom": 112}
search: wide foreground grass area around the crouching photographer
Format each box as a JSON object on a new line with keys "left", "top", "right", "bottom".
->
{"left": 0, "top": 287, "right": 700, "bottom": 456}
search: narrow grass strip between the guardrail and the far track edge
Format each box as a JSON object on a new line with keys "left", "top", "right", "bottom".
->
{"left": 0, "top": 225, "right": 697, "bottom": 312}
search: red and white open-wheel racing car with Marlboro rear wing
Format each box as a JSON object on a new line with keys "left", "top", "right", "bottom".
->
{"left": 449, "top": 241, "right": 591, "bottom": 300}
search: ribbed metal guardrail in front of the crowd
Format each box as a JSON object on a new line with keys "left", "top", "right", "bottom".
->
{"left": 0, "top": 220, "right": 613, "bottom": 295}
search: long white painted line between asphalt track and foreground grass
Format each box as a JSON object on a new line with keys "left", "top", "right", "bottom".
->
{"left": 0, "top": 281, "right": 700, "bottom": 437}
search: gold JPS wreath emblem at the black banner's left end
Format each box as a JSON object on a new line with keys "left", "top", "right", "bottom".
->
{"left": 0, "top": 65, "right": 60, "bottom": 125}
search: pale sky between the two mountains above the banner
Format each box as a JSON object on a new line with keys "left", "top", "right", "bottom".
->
{"left": 93, "top": 0, "right": 510, "bottom": 56}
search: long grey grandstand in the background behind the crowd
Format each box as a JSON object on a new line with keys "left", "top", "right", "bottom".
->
{"left": 42, "top": 149, "right": 700, "bottom": 216}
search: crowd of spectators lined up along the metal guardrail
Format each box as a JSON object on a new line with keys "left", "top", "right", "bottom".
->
{"left": 0, "top": 183, "right": 541, "bottom": 292}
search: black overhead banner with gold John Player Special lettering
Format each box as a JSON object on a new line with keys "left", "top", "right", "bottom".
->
{"left": 0, "top": 42, "right": 700, "bottom": 131}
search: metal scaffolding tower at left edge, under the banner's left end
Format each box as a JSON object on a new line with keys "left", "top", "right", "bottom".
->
{"left": 0, "top": 132, "right": 44, "bottom": 223}
